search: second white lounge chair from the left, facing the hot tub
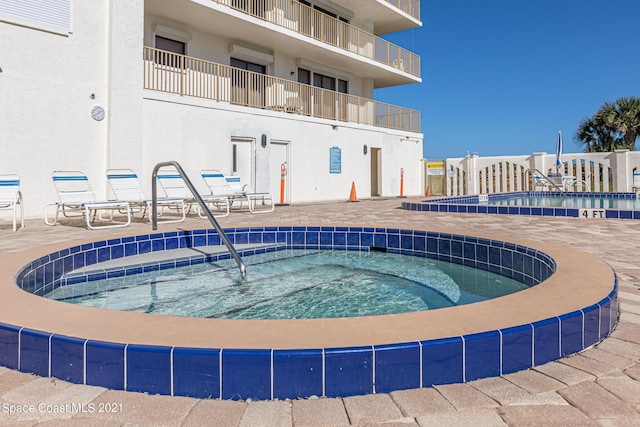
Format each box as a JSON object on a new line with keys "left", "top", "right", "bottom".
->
{"left": 44, "top": 171, "right": 131, "bottom": 230}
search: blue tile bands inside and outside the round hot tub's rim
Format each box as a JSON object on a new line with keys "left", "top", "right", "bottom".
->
{"left": 0, "top": 227, "right": 618, "bottom": 399}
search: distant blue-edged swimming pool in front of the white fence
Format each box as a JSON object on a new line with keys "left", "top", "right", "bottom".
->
{"left": 402, "top": 191, "right": 640, "bottom": 219}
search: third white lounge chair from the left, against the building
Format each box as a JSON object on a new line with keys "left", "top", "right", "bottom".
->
{"left": 107, "top": 169, "right": 187, "bottom": 224}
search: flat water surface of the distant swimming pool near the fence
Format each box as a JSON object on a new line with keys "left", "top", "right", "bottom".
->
{"left": 486, "top": 195, "right": 640, "bottom": 210}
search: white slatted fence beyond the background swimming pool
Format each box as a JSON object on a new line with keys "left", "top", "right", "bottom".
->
{"left": 444, "top": 150, "right": 640, "bottom": 196}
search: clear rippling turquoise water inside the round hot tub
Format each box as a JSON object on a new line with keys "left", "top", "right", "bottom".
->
{"left": 46, "top": 250, "right": 527, "bottom": 319}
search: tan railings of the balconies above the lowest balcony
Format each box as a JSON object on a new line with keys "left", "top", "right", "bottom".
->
{"left": 212, "top": 0, "right": 420, "bottom": 77}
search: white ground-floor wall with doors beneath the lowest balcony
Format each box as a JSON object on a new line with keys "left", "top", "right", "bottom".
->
{"left": 139, "top": 91, "right": 423, "bottom": 203}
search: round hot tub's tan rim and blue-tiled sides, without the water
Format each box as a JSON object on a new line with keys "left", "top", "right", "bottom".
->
{"left": 0, "top": 226, "right": 618, "bottom": 399}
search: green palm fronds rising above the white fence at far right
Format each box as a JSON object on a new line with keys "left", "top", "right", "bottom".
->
{"left": 575, "top": 97, "right": 640, "bottom": 152}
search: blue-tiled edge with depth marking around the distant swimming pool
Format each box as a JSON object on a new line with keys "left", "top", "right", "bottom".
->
{"left": 401, "top": 191, "right": 640, "bottom": 219}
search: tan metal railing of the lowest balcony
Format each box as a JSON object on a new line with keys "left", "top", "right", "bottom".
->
{"left": 144, "top": 47, "right": 420, "bottom": 132}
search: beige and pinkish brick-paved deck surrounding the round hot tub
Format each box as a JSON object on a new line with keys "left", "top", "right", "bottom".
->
{"left": 0, "top": 199, "right": 640, "bottom": 426}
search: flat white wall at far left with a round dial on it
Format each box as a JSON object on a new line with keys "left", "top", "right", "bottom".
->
{"left": 0, "top": 1, "right": 109, "bottom": 216}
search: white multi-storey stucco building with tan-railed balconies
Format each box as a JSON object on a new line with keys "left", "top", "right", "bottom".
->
{"left": 0, "top": 0, "right": 424, "bottom": 217}
